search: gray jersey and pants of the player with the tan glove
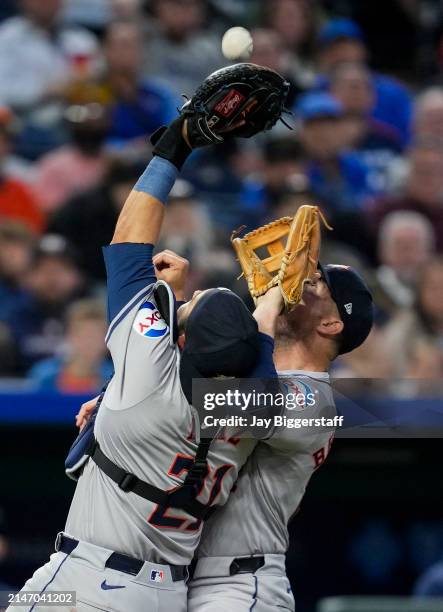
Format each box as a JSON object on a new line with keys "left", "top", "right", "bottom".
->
{"left": 188, "top": 371, "right": 336, "bottom": 612}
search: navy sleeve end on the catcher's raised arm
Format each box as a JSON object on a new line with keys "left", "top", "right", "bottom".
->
{"left": 103, "top": 242, "right": 156, "bottom": 322}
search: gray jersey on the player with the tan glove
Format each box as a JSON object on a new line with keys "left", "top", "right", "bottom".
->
{"left": 197, "top": 371, "right": 336, "bottom": 558}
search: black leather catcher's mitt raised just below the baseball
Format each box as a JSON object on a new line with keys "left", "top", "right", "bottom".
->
{"left": 180, "top": 63, "right": 289, "bottom": 149}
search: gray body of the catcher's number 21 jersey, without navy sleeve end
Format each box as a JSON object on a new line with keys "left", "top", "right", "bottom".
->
{"left": 65, "top": 287, "right": 254, "bottom": 564}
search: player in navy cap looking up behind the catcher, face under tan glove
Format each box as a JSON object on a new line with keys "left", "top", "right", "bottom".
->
{"left": 188, "top": 265, "right": 373, "bottom": 612}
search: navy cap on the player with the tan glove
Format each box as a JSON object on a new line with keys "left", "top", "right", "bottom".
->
{"left": 318, "top": 264, "right": 374, "bottom": 355}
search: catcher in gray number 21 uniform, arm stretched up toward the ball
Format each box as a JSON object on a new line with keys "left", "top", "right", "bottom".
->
{"left": 13, "top": 111, "right": 280, "bottom": 612}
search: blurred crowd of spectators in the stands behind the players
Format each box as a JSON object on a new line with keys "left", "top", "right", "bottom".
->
{"left": 0, "top": 0, "right": 443, "bottom": 396}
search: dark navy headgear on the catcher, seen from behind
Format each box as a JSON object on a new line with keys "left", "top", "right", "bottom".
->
{"left": 180, "top": 288, "right": 260, "bottom": 403}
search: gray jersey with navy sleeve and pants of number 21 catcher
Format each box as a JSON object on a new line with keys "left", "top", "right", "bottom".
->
{"left": 11, "top": 243, "right": 255, "bottom": 612}
